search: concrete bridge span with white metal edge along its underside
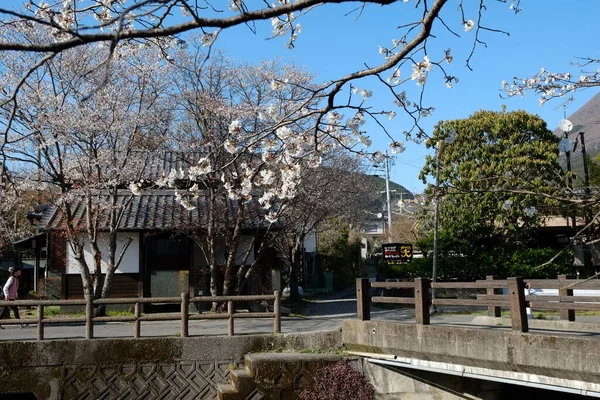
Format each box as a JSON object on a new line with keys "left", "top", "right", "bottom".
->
{"left": 342, "top": 320, "right": 600, "bottom": 398}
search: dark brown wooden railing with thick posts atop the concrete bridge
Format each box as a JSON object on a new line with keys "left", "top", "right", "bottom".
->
{"left": 356, "top": 275, "right": 600, "bottom": 332}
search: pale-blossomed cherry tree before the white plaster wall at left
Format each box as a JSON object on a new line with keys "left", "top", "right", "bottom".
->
{"left": 0, "top": 29, "right": 171, "bottom": 313}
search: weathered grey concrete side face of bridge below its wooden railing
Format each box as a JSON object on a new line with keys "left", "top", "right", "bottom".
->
{"left": 342, "top": 320, "right": 600, "bottom": 384}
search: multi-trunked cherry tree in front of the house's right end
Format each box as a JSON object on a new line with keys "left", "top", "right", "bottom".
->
{"left": 157, "top": 48, "right": 346, "bottom": 295}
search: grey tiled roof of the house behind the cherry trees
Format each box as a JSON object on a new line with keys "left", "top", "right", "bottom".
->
{"left": 32, "top": 190, "right": 266, "bottom": 231}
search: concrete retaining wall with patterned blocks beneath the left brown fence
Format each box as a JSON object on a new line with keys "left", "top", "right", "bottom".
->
{"left": 0, "top": 331, "right": 341, "bottom": 400}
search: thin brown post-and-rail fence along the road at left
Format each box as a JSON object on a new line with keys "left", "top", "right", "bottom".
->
{"left": 0, "top": 291, "right": 281, "bottom": 340}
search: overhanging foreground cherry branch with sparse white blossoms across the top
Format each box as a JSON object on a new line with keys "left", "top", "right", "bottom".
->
{"left": 0, "top": 0, "right": 520, "bottom": 162}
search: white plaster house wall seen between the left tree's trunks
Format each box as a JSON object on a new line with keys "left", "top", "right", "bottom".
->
{"left": 67, "top": 232, "right": 140, "bottom": 274}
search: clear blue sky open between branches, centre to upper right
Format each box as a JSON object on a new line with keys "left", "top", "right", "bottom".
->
{"left": 207, "top": 0, "right": 600, "bottom": 192}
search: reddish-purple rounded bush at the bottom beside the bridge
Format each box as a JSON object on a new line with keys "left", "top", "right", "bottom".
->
{"left": 299, "top": 361, "right": 375, "bottom": 400}
